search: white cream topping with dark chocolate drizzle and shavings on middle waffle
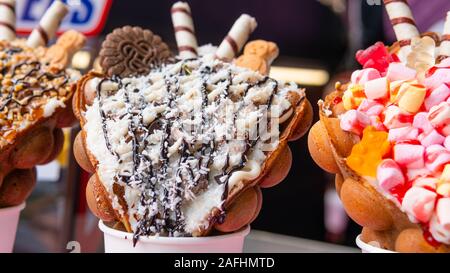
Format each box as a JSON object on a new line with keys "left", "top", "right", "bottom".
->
{"left": 84, "top": 55, "right": 304, "bottom": 239}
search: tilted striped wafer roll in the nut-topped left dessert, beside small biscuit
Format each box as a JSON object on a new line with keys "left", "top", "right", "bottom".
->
{"left": 27, "top": 1, "right": 69, "bottom": 47}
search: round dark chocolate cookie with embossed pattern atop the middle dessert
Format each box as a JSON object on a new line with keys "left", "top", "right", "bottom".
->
{"left": 100, "top": 26, "right": 171, "bottom": 77}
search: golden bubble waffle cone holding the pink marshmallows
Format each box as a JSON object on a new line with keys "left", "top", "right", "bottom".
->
{"left": 309, "top": 77, "right": 450, "bottom": 252}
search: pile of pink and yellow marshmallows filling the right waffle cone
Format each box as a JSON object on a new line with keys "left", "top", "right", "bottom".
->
{"left": 339, "top": 43, "right": 450, "bottom": 244}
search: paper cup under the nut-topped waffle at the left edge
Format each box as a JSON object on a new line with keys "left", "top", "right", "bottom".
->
{"left": 0, "top": 202, "right": 25, "bottom": 253}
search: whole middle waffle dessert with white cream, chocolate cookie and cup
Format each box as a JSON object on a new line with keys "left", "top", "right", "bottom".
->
{"left": 74, "top": 2, "right": 312, "bottom": 252}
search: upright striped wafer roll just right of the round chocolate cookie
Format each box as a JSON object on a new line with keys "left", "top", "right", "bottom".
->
{"left": 170, "top": 2, "right": 197, "bottom": 59}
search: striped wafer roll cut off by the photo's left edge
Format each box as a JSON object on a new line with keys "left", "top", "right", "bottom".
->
{"left": 0, "top": 0, "right": 16, "bottom": 41}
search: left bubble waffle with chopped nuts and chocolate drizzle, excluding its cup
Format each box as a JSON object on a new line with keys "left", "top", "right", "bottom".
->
{"left": 0, "top": 32, "right": 84, "bottom": 207}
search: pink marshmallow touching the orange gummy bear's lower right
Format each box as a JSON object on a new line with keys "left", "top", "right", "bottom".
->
{"left": 377, "top": 159, "right": 405, "bottom": 191}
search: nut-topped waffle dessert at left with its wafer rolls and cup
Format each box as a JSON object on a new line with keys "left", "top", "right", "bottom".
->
{"left": 0, "top": 0, "right": 85, "bottom": 252}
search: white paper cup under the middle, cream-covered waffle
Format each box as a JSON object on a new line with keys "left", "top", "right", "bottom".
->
{"left": 98, "top": 221, "right": 250, "bottom": 253}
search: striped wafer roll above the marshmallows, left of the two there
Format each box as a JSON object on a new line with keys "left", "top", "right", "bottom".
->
{"left": 384, "top": 0, "right": 420, "bottom": 62}
